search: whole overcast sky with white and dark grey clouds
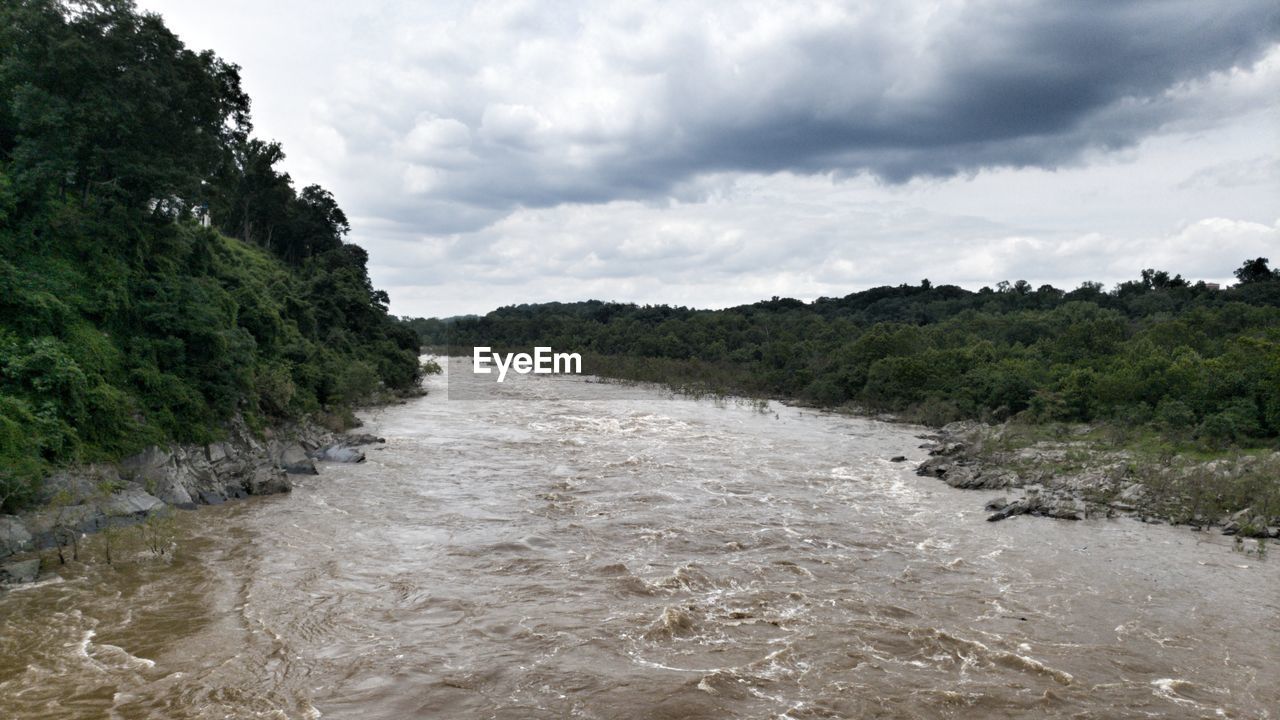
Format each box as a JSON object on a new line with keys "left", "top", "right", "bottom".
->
{"left": 138, "top": 0, "right": 1280, "bottom": 316}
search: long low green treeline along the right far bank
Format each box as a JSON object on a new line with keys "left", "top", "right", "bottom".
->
{"left": 407, "top": 258, "right": 1280, "bottom": 445}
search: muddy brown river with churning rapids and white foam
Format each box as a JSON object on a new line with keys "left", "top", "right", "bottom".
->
{"left": 0, "top": 360, "right": 1280, "bottom": 720}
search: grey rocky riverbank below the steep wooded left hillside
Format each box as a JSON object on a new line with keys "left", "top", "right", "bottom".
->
{"left": 0, "top": 420, "right": 383, "bottom": 583}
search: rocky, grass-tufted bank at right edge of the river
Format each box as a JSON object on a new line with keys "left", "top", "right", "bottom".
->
{"left": 916, "top": 421, "right": 1280, "bottom": 538}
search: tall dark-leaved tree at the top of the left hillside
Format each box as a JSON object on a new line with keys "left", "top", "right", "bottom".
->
{"left": 0, "top": 0, "right": 250, "bottom": 206}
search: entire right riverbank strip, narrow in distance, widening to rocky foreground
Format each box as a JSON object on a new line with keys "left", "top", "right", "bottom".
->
{"left": 560, "top": 357, "right": 1280, "bottom": 539}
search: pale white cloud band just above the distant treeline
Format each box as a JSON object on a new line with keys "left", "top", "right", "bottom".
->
{"left": 375, "top": 170, "right": 1280, "bottom": 315}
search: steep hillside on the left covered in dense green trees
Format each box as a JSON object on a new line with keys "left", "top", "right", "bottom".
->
{"left": 0, "top": 0, "right": 419, "bottom": 510}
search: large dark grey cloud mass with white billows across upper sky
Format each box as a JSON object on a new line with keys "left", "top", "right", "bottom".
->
{"left": 307, "top": 0, "right": 1280, "bottom": 228}
